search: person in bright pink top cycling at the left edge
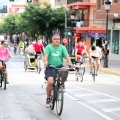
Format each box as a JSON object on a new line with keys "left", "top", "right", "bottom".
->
{"left": 0, "top": 41, "right": 11, "bottom": 84}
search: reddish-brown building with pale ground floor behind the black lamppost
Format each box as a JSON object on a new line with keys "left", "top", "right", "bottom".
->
{"left": 96, "top": 0, "right": 120, "bottom": 60}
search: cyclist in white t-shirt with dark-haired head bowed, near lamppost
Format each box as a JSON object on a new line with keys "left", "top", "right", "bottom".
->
{"left": 89, "top": 45, "right": 102, "bottom": 76}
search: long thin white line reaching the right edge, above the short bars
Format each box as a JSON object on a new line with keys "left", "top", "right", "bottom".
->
{"left": 69, "top": 85, "right": 120, "bottom": 101}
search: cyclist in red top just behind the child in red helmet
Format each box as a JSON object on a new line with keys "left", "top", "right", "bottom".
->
{"left": 75, "top": 41, "right": 88, "bottom": 60}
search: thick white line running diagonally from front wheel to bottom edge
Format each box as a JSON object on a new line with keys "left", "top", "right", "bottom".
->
{"left": 65, "top": 93, "right": 114, "bottom": 120}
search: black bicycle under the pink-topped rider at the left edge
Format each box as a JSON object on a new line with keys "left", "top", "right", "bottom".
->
{"left": 0, "top": 60, "right": 7, "bottom": 90}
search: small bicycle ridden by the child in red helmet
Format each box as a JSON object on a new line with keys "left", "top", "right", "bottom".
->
{"left": 76, "top": 64, "right": 85, "bottom": 82}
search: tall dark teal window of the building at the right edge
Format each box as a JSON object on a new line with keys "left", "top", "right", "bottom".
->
{"left": 112, "top": 30, "right": 119, "bottom": 54}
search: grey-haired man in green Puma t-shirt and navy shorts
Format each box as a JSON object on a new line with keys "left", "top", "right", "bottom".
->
{"left": 44, "top": 34, "right": 71, "bottom": 107}
